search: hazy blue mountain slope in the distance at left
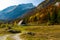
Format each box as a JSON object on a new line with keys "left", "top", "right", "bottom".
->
{"left": 0, "top": 3, "right": 35, "bottom": 21}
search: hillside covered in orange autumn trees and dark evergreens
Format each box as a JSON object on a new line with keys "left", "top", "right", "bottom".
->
{"left": 24, "top": 0, "right": 60, "bottom": 24}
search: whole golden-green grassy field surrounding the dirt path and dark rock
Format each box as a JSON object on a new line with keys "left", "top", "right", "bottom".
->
{"left": 0, "top": 25, "right": 60, "bottom": 40}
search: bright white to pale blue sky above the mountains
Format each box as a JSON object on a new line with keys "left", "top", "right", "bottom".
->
{"left": 0, "top": 0, "right": 44, "bottom": 10}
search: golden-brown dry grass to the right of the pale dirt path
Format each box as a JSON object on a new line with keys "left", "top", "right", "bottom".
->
{"left": 20, "top": 25, "right": 60, "bottom": 40}
